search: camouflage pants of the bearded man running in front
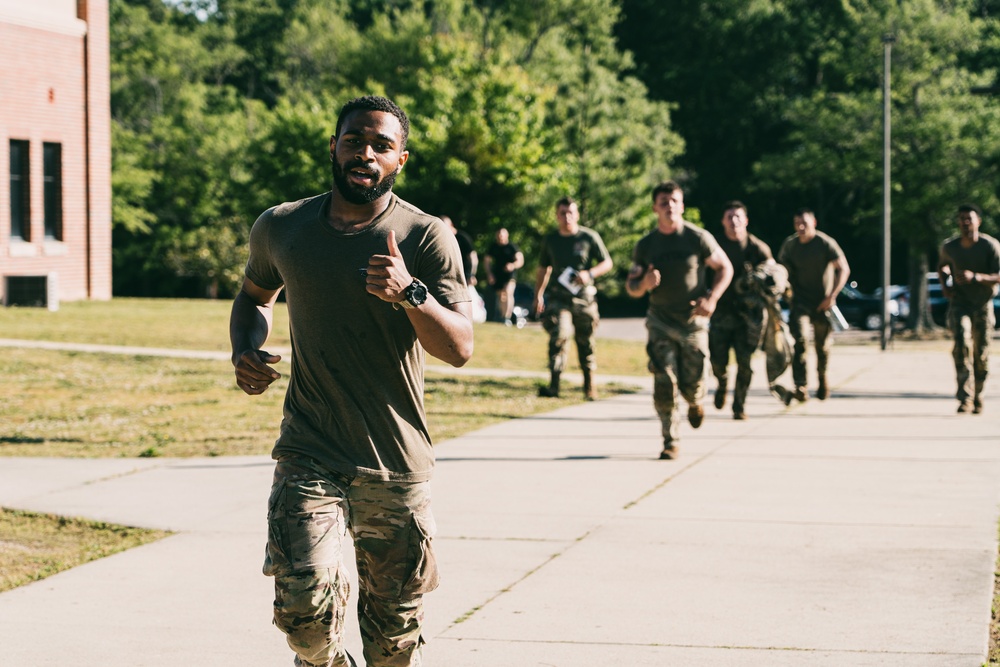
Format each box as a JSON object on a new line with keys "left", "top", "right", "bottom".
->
{"left": 264, "top": 459, "right": 438, "bottom": 667}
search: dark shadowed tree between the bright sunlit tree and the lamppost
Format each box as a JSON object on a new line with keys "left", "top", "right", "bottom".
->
{"left": 616, "top": 0, "right": 828, "bottom": 237}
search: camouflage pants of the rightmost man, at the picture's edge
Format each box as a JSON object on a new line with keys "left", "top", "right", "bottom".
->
{"left": 948, "top": 301, "right": 996, "bottom": 401}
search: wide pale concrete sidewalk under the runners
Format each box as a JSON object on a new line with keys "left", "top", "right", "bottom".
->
{"left": 0, "top": 344, "right": 1000, "bottom": 667}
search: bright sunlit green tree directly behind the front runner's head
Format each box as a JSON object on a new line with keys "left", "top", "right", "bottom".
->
{"left": 268, "top": 0, "right": 682, "bottom": 284}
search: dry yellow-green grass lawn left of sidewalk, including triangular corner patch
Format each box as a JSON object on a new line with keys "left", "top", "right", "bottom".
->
{"left": 0, "top": 299, "right": 646, "bottom": 591}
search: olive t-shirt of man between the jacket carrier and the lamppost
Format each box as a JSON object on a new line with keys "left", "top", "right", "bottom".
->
{"left": 778, "top": 230, "right": 844, "bottom": 313}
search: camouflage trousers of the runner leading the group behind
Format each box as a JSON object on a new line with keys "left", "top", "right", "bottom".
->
{"left": 646, "top": 313, "right": 708, "bottom": 442}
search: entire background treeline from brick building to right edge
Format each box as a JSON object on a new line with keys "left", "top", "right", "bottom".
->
{"left": 111, "top": 0, "right": 1000, "bottom": 328}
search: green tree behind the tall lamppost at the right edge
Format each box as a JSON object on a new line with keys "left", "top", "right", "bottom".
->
{"left": 756, "top": 0, "right": 1000, "bottom": 329}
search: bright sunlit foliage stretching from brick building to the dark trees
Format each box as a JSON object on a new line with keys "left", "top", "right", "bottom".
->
{"left": 112, "top": 0, "right": 682, "bottom": 295}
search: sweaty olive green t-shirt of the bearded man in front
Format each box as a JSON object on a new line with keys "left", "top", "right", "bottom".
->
{"left": 246, "top": 193, "right": 469, "bottom": 481}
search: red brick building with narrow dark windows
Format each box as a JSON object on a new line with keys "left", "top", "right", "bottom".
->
{"left": 0, "top": 0, "right": 111, "bottom": 308}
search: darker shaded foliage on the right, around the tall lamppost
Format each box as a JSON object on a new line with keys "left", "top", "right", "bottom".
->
{"left": 618, "top": 0, "right": 1000, "bottom": 310}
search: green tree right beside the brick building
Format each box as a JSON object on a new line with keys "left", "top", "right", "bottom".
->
{"left": 110, "top": 0, "right": 253, "bottom": 295}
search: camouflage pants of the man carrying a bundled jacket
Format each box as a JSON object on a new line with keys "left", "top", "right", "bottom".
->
{"left": 708, "top": 312, "right": 764, "bottom": 412}
